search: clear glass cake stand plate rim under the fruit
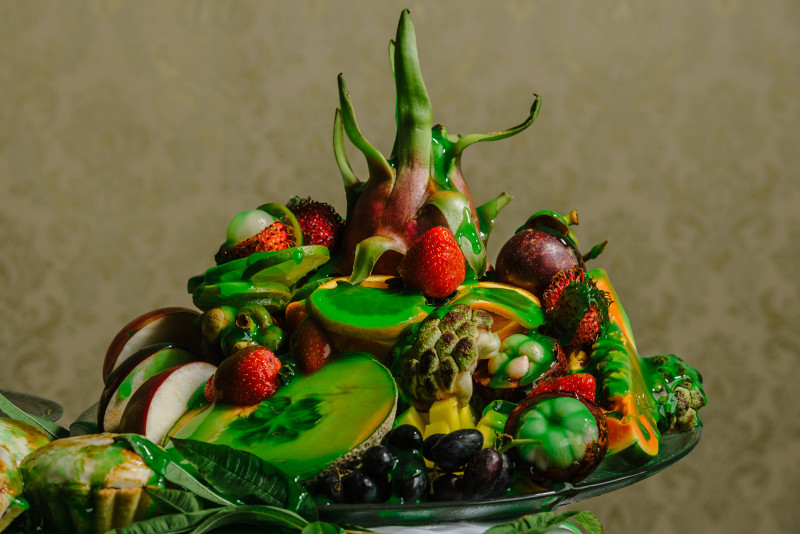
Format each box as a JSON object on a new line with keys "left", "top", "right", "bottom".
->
{"left": 319, "top": 423, "right": 702, "bottom": 528}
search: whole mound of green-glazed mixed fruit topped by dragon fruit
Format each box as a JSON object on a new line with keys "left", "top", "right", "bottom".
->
{"left": 0, "top": 12, "right": 706, "bottom": 534}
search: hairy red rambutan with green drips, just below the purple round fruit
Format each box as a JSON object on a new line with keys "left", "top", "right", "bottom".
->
{"left": 542, "top": 268, "right": 611, "bottom": 350}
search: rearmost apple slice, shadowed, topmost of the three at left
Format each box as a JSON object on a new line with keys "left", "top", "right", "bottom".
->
{"left": 103, "top": 307, "right": 201, "bottom": 382}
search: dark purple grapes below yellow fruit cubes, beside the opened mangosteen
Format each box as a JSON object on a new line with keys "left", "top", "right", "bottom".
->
{"left": 422, "top": 429, "right": 514, "bottom": 501}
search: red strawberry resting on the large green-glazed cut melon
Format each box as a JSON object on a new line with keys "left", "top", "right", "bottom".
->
{"left": 213, "top": 345, "right": 281, "bottom": 406}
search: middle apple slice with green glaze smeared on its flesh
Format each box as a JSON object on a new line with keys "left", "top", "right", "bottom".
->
{"left": 97, "top": 343, "right": 199, "bottom": 432}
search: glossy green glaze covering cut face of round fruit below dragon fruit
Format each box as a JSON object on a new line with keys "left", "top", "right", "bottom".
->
{"left": 309, "top": 282, "right": 433, "bottom": 328}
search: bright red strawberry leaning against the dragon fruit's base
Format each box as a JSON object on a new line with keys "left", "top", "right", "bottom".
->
{"left": 397, "top": 226, "right": 466, "bottom": 298}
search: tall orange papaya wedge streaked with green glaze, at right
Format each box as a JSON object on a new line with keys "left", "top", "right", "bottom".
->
{"left": 589, "top": 269, "right": 661, "bottom": 464}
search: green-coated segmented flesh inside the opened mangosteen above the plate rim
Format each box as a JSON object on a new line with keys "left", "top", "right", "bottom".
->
{"left": 515, "top": 397, "right": 599, "bottom": 469}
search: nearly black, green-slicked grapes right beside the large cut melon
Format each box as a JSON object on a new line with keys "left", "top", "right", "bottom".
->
{"left": 310, "top": 425, "right": 428, "bottom": 504}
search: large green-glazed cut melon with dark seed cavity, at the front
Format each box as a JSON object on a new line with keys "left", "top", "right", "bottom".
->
{"left": 170, "top": 353, "right": 397, "bottom": 480}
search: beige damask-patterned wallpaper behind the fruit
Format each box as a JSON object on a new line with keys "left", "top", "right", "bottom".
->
{"left": 0, "top": 0, "right": 800, "bottom": 533}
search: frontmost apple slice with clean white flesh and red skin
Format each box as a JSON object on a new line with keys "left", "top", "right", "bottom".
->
{"left": 119, "top": 362, "right": 217, "bottom": 443}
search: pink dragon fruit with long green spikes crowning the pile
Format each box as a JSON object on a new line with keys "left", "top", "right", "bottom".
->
{"left": 333, "top": 10, "right": 541, "bottom": 283}
